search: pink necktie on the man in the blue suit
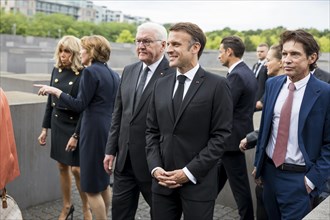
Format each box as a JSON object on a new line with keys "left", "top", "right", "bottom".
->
{"left": 273, "top": 83, "right": 295, "bottom": 167}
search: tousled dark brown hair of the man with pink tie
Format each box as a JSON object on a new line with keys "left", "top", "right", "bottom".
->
{"left": 280, "top": 29, "right": 320, "bottom": 70}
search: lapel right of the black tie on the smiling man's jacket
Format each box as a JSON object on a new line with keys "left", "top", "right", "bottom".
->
{"left": 172, "top": 67, "right": 205, "bottom": 123}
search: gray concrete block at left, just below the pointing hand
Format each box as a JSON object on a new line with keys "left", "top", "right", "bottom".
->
{"left": 6, "top": 91, "right": 61, "bottom": 209}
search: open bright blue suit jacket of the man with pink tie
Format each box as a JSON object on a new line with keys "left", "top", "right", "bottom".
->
{"left": 255, "top": 75, "right": 330, "bottom": 194}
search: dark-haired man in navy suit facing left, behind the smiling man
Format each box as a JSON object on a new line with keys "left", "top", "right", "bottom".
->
{"left": 218, "top": 36, "right": 258, "bottom": 220}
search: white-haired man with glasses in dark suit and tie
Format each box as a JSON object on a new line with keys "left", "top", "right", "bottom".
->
{"left": 104, "top": 23, "right": 174, "bottom": 220}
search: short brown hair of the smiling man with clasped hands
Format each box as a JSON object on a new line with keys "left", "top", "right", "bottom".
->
{"left": 169, "top": 22, "right": 206, "bottom": 59}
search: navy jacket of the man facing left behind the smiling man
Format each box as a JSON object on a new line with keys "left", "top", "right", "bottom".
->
{"left": 225, "top": 62, "right": 258, "bottom": 151}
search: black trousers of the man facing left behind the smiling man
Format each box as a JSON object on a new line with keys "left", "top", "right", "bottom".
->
{"left": 218, "top": 151, "right": 254, "bottom": 220}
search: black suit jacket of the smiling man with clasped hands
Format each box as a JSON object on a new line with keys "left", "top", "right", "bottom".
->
{"left": 146, "top": 67, "right": 232, "bottom": 201}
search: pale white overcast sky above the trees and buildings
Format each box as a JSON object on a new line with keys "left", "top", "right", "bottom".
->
{"left": 93, "top": 0, "right": 330, "bottom": 32}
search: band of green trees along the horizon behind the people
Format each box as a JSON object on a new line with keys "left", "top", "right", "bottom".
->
{"left": 0, "top": 11, "right": 330, "bottom": 52}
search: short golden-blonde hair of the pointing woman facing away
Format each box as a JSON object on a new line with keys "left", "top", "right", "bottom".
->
{"left": 81, "top": 35, "right": 111, "bottom": 63}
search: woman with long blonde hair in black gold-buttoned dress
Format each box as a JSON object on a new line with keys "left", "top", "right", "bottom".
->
{"left": 38, "top": 36, "right": 92, "bottom": 220}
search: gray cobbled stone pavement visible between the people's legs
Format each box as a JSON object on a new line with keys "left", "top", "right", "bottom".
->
{"left": 22, "top": 181, "right": 239, "bottom": 220}
